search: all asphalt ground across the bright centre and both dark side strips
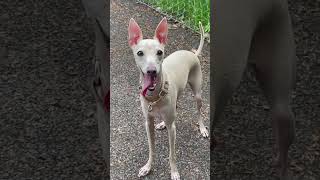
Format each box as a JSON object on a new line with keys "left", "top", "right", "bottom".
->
{"left": 0, "top": 0, "right": 320, "bottom": 180}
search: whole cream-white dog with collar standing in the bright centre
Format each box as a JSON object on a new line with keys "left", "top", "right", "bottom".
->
{"left": 128, "top": 18, "right": 208, "bottom": 180}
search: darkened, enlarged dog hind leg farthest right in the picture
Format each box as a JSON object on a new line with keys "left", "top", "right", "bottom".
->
{"left": 252, "top": 1, "right": 296, "bottom": 179}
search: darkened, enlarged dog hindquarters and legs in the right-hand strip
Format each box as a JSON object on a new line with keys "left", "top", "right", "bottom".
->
{"left": 210, "top": 0, "right": 296, "bottom": 179}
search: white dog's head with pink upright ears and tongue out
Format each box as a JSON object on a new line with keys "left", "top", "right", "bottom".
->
{"left": 128, "top": 18, "right": 168, "bottom": 94}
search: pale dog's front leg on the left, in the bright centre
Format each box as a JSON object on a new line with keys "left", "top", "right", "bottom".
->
{"left": 138, "top": 112, "right": 155, "bottom": 177}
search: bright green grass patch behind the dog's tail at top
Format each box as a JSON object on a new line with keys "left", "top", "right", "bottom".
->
{"left": 139, "top": 0, "right": 210, "bottom": 32}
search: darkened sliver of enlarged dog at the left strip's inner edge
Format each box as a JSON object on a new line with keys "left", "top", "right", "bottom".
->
{"left": 82, "top": 0, "right": 110, "bottom": 176}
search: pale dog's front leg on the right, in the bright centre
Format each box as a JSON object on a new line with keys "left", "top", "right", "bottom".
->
{"left": 165, "top": 111, "right": 180, "bottom": 180}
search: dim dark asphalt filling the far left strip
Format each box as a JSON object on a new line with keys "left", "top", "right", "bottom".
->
{"left": 0, "top": 1, "right": 106, "bottom": 180}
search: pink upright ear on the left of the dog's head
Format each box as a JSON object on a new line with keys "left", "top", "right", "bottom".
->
{"left": 128, "top": 18, "right": 143, "bottom": 47}
